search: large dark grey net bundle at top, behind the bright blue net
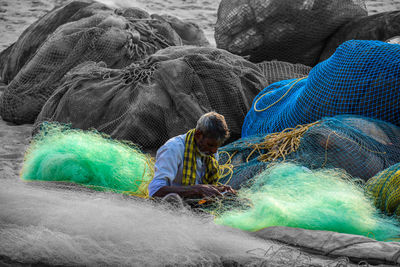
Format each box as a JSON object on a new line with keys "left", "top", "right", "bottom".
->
{"left": 215, "top": 0, "right": 367, "bottom": 66}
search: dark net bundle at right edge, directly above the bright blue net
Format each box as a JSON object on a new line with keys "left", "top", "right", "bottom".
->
{"left": 319, "top": 11, "right": 400, "bottom": 61}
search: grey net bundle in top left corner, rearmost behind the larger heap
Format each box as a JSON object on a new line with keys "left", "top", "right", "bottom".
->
{"left": 0, "top": 0, "right": 113, "bottom": 84}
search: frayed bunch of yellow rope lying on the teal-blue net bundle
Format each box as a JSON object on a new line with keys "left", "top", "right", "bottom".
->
{"left": 246, "top": 121, "right": 320, "bottom": 162}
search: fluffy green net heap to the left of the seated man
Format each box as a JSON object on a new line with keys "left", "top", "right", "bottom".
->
{"left": 21, "top": 123, "right": 154, "bottom": 197}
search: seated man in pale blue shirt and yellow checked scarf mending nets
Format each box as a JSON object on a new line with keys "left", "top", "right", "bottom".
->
{"left": 149, "top": 112, "right": 235, "bottom": 198}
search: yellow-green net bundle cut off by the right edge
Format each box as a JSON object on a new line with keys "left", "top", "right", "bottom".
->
{"left": 365, "top": 163, "right": 400, "bottom": 218}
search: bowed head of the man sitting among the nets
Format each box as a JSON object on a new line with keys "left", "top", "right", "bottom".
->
{"left": 194, "top": 112, "right": 229, "bottom": 155}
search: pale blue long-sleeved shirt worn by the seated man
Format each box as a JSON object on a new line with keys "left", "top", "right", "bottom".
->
{"left": 149, "top": 134, "right": 218, "bottom": 197}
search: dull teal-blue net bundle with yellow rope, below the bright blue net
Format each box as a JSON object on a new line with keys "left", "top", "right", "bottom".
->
{"left": 219, "top": 115, "right": 400, "bottom": 188}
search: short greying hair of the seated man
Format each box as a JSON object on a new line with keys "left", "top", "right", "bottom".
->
{"left": 196, "top": 111, "right": 229, "bottom": 143}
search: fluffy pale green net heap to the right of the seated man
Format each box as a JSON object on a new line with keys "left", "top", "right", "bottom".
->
{"left": 214, "top": 163, "right": 400, "bottom": 241}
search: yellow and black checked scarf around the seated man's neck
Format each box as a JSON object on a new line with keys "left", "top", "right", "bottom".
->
{"left": 182, "top": 129, "right": 220, "bottom": 185}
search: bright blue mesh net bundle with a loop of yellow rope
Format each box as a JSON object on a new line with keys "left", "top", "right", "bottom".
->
{"left": 242, "top": 40, "right": 400, "bottom": 137}
